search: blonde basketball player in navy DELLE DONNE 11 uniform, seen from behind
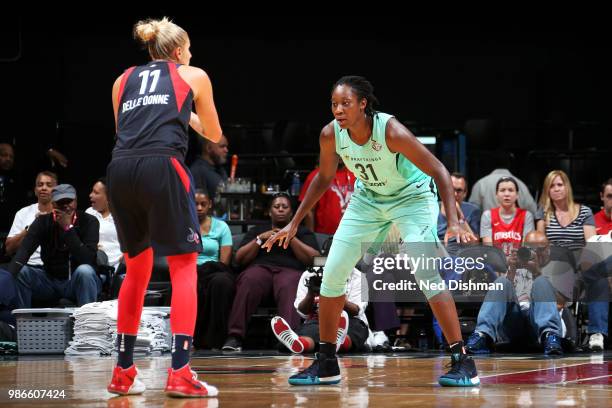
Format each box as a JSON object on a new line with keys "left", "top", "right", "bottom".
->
{"left": 107, "top": 18, "right": 221, "bottom": 397}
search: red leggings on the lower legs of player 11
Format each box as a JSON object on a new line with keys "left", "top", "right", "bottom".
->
{"left": 117, "top": 248, "right": 198, "bottom": 336}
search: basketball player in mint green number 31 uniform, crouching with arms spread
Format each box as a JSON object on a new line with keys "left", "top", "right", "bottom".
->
{"left": 263, "top": 76, "right": 480, "bottom": 387}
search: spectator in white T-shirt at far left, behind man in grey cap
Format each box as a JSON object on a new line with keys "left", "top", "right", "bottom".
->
{"left": 5, "top": 171, "right": 57, "bottom": 266}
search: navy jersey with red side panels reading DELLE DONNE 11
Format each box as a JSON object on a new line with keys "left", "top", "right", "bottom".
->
{"left": 113, "top": 61, "right": 193, "bottom": 157}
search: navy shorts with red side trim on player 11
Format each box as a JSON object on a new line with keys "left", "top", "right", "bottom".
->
{"left": 107, "top": 155, "right": 202, "bottom": 257}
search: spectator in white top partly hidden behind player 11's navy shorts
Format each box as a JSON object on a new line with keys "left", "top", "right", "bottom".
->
{"left": 85, "top": 177, "right": 123, "bottom": 270}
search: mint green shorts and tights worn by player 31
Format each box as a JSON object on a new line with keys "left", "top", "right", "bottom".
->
{"left": 321, "top": 183, "right": 446, "bottom": 299}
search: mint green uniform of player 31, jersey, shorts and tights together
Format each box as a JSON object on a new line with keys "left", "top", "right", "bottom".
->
{"left": 321, "top": 112, "right": 443, "bottom": 299}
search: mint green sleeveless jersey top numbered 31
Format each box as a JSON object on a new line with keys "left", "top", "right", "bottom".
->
{"left": 334, "top": 112, "right": 430, "bottom": 196}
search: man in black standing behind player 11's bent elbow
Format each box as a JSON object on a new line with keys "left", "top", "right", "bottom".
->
{"left": 189, "top": 135, "right": 228, "bottom": 200}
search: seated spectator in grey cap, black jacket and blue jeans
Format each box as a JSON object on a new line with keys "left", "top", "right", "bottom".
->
{"left": 9, "top": 184, "right": 101, "bottom": 308}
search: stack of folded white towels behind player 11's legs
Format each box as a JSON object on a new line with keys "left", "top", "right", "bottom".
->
{"left": 65, "top": 300, "right": 172, "bottom": 355}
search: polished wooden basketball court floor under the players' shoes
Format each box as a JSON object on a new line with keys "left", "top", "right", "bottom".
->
{"left": 0, "top": 351, "right": 612, "bottom": 408}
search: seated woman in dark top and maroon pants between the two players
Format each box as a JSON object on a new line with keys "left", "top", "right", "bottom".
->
{"left": 223, "top": 193, "right": 320, "bottom": 351}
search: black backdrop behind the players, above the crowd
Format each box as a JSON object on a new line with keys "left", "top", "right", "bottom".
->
{"left": 0, "top": 12, "right": 612, "bottom": 206}
